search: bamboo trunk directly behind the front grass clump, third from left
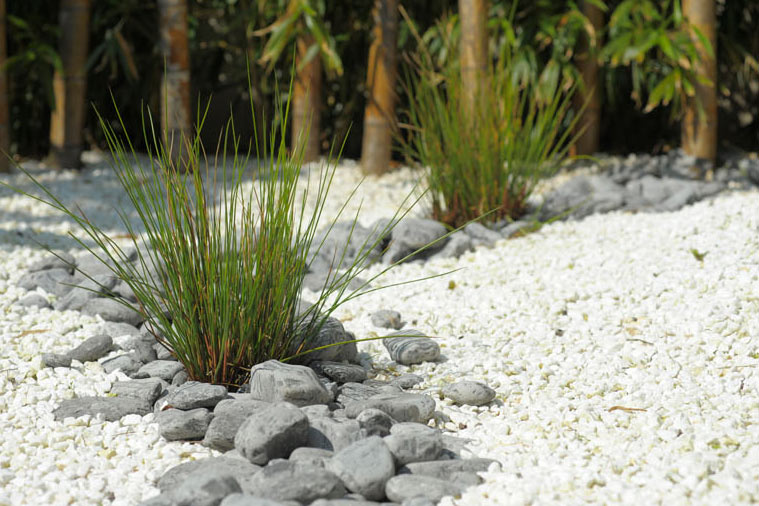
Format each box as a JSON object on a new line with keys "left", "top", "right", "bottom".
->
{"left": 158, "top": 0, "right": 192, "bottom": 170}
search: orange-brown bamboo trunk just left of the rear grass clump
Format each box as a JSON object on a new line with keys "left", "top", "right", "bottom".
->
{"left": 361, "top": 0, "right": 398, "bottom": 174}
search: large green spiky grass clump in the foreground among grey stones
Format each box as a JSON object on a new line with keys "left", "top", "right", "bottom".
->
{"left": 5, "top": 87, "right": 430, "bottom": 388}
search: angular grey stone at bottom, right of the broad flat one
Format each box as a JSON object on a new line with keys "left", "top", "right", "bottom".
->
{"left": 327, "top": 436, "right": 395, "bottom": 501}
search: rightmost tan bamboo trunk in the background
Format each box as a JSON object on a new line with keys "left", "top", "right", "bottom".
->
{"left": 680, "top": 0, "right": 717, "bottom": 162}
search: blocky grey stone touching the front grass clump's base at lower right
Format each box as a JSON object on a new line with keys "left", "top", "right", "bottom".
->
{"left": 250, "top": 360, "right": 332, "bottom": 406}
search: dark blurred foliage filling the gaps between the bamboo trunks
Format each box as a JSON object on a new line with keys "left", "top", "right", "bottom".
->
{"left": 2, "top": 0, "right": 759, "bottom": 158}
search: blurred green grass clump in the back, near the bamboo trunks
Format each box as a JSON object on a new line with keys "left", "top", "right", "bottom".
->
{"left": 402, "top": 30, "right": 576, "bottom": 227}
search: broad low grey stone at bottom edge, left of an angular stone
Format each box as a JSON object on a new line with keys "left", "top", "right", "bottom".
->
{"left": 241, "top": 460, "right": 345, "bottom": 504}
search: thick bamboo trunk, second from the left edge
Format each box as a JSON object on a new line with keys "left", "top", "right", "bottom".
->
{"left": 50, "top": 0, "right": 91, "bottom": 168}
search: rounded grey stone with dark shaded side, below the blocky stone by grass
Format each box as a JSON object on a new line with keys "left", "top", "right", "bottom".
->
{"left": 235, "top": 402, "right": 310, "bottom": 465}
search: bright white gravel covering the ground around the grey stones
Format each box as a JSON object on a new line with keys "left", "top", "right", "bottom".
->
{"left": 0, "top": 155, "right": 759, "bottom": 505}
